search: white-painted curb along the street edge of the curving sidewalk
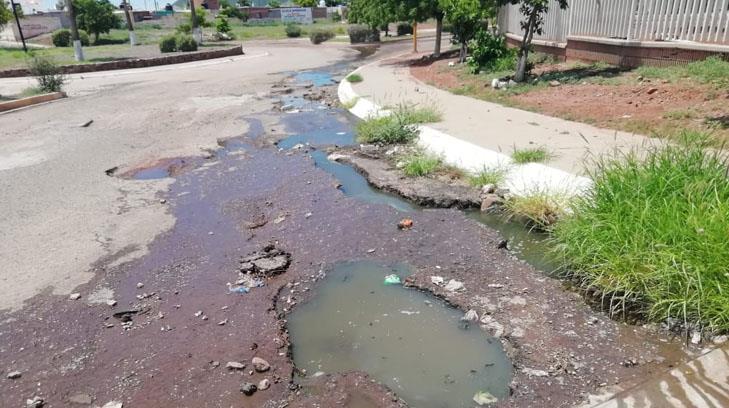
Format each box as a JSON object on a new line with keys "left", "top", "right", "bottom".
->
{"left": 337, "top": 65, "right": 592, "bottom": 199}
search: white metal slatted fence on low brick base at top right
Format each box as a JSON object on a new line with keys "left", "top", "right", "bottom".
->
{"left": 499, "top": 0, "right": 729, "bottom": 45}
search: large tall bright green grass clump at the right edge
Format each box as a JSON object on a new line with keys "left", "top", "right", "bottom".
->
{"left": 553, "top": 133, "right": 729, "bottom": 332}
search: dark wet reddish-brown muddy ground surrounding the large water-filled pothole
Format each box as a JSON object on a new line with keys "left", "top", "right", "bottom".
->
{"left": 0, "top": 56, "right": 687, "bottom": 408}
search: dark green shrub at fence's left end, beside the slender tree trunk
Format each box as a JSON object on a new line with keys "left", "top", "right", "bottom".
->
{"left": 466, "top": 30, "right": 516, "bottom": 74}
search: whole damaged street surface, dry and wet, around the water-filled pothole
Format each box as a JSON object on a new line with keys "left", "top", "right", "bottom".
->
{"left": 0, "top": 42, "right": 687, "bottom": 408}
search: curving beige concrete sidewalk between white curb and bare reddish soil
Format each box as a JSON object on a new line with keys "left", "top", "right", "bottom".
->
{"left": 346, "top": 54, "right": 656, "bottom": 175}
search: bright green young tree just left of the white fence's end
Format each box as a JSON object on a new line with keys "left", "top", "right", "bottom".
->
{"left": 440, "top": 0, "right": 495, "bottom": 63}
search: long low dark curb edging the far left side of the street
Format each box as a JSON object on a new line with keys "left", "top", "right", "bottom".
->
{"left": 0, "top": 45, "right": 244, "bottom": 78}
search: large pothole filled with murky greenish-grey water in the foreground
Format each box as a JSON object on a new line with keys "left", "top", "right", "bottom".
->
{"left": 288, "top": 261, "right": 512, "bottom": 408}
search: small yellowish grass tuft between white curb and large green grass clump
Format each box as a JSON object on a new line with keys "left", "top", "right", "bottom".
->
{"left": 504, "top": 191, "right": 567, "bottom": 230}
